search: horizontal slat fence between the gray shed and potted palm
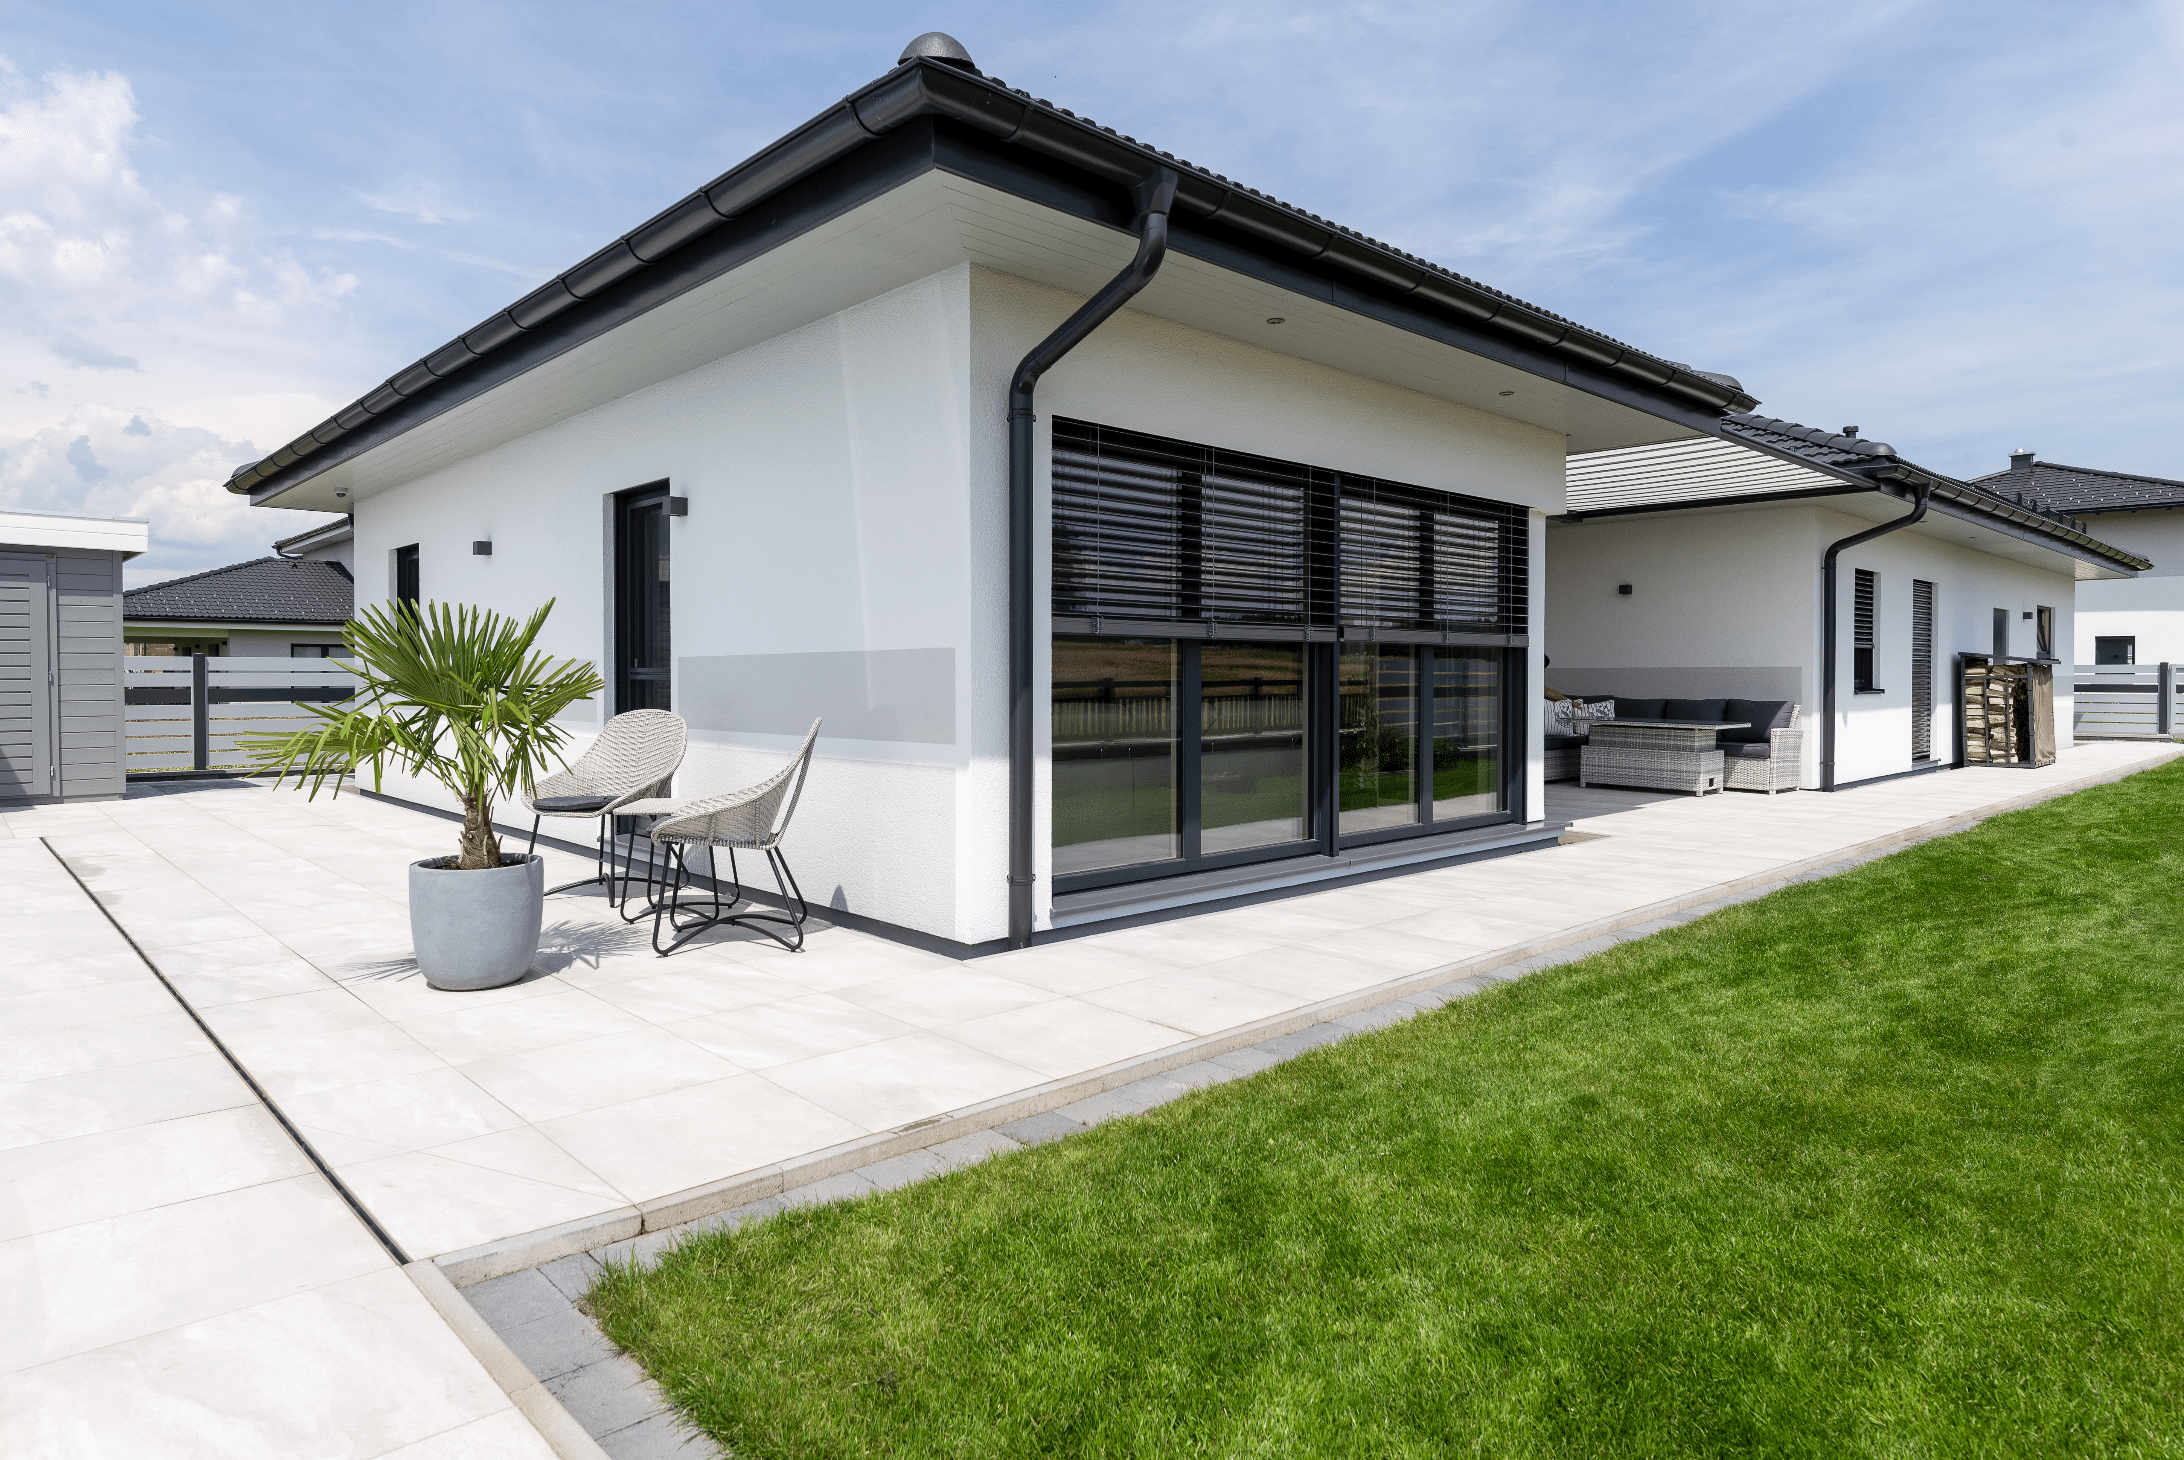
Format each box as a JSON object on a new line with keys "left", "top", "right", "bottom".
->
{"left": 122, "top": 656, "right": 356, "bottom": 776}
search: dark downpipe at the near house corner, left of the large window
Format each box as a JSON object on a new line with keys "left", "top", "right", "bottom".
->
{"left": 1009, "top": 168, "right": 1177, "bottom": 949}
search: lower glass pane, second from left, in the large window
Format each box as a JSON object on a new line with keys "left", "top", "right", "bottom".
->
{"left": 1199, "top": 645, "right": 1306, "bottom": 857}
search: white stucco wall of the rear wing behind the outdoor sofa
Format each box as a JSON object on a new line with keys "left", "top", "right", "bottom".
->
{"left": 1546, "top": 503, "right": 2073, "bottom": 787}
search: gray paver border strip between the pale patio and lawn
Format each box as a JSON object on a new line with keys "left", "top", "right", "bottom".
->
{"left": 441, "top": 761, "right": 2162, "bottom": 1460}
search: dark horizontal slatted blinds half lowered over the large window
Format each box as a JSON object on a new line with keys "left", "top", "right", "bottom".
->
{"left": 1053, "top": 420, "right": 1527, "bottom": 638}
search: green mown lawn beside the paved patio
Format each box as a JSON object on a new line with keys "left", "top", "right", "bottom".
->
{"left": 592, "top": 765, "right": 2184, "bottom": 1458}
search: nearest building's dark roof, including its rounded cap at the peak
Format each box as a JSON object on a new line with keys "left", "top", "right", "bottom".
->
{"left": 227, "top": 33, "right": 1758, "bottom": 501}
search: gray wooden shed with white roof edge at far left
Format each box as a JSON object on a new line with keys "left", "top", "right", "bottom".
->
{"left": 0, "top": 511, "right": 151, "bottom": 802}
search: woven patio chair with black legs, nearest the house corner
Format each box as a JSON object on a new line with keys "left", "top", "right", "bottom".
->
{"left": 640, "top": 719, "right": 819, "bottom": 957}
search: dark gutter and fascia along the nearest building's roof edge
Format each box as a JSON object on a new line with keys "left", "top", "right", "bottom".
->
{"left": 227, "top": 57, "right": 1758, "bottom": 494}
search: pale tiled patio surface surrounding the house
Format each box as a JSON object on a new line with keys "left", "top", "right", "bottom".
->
{"left": 0, "top": 743, "right": 2180, "bottom": 1456}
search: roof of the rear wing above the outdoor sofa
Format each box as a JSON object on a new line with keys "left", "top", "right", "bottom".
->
{"left": 1568, "top": 415, "right": 2153, "bottom": 573}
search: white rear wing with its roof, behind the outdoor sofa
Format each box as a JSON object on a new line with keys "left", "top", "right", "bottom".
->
{"left": 1546, "top": 415, "right": 2149, "bottom": 789}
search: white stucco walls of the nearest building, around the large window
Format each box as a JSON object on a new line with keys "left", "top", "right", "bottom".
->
{"left": 340, "top": 264, "right": 1564, "bottom": 944}
